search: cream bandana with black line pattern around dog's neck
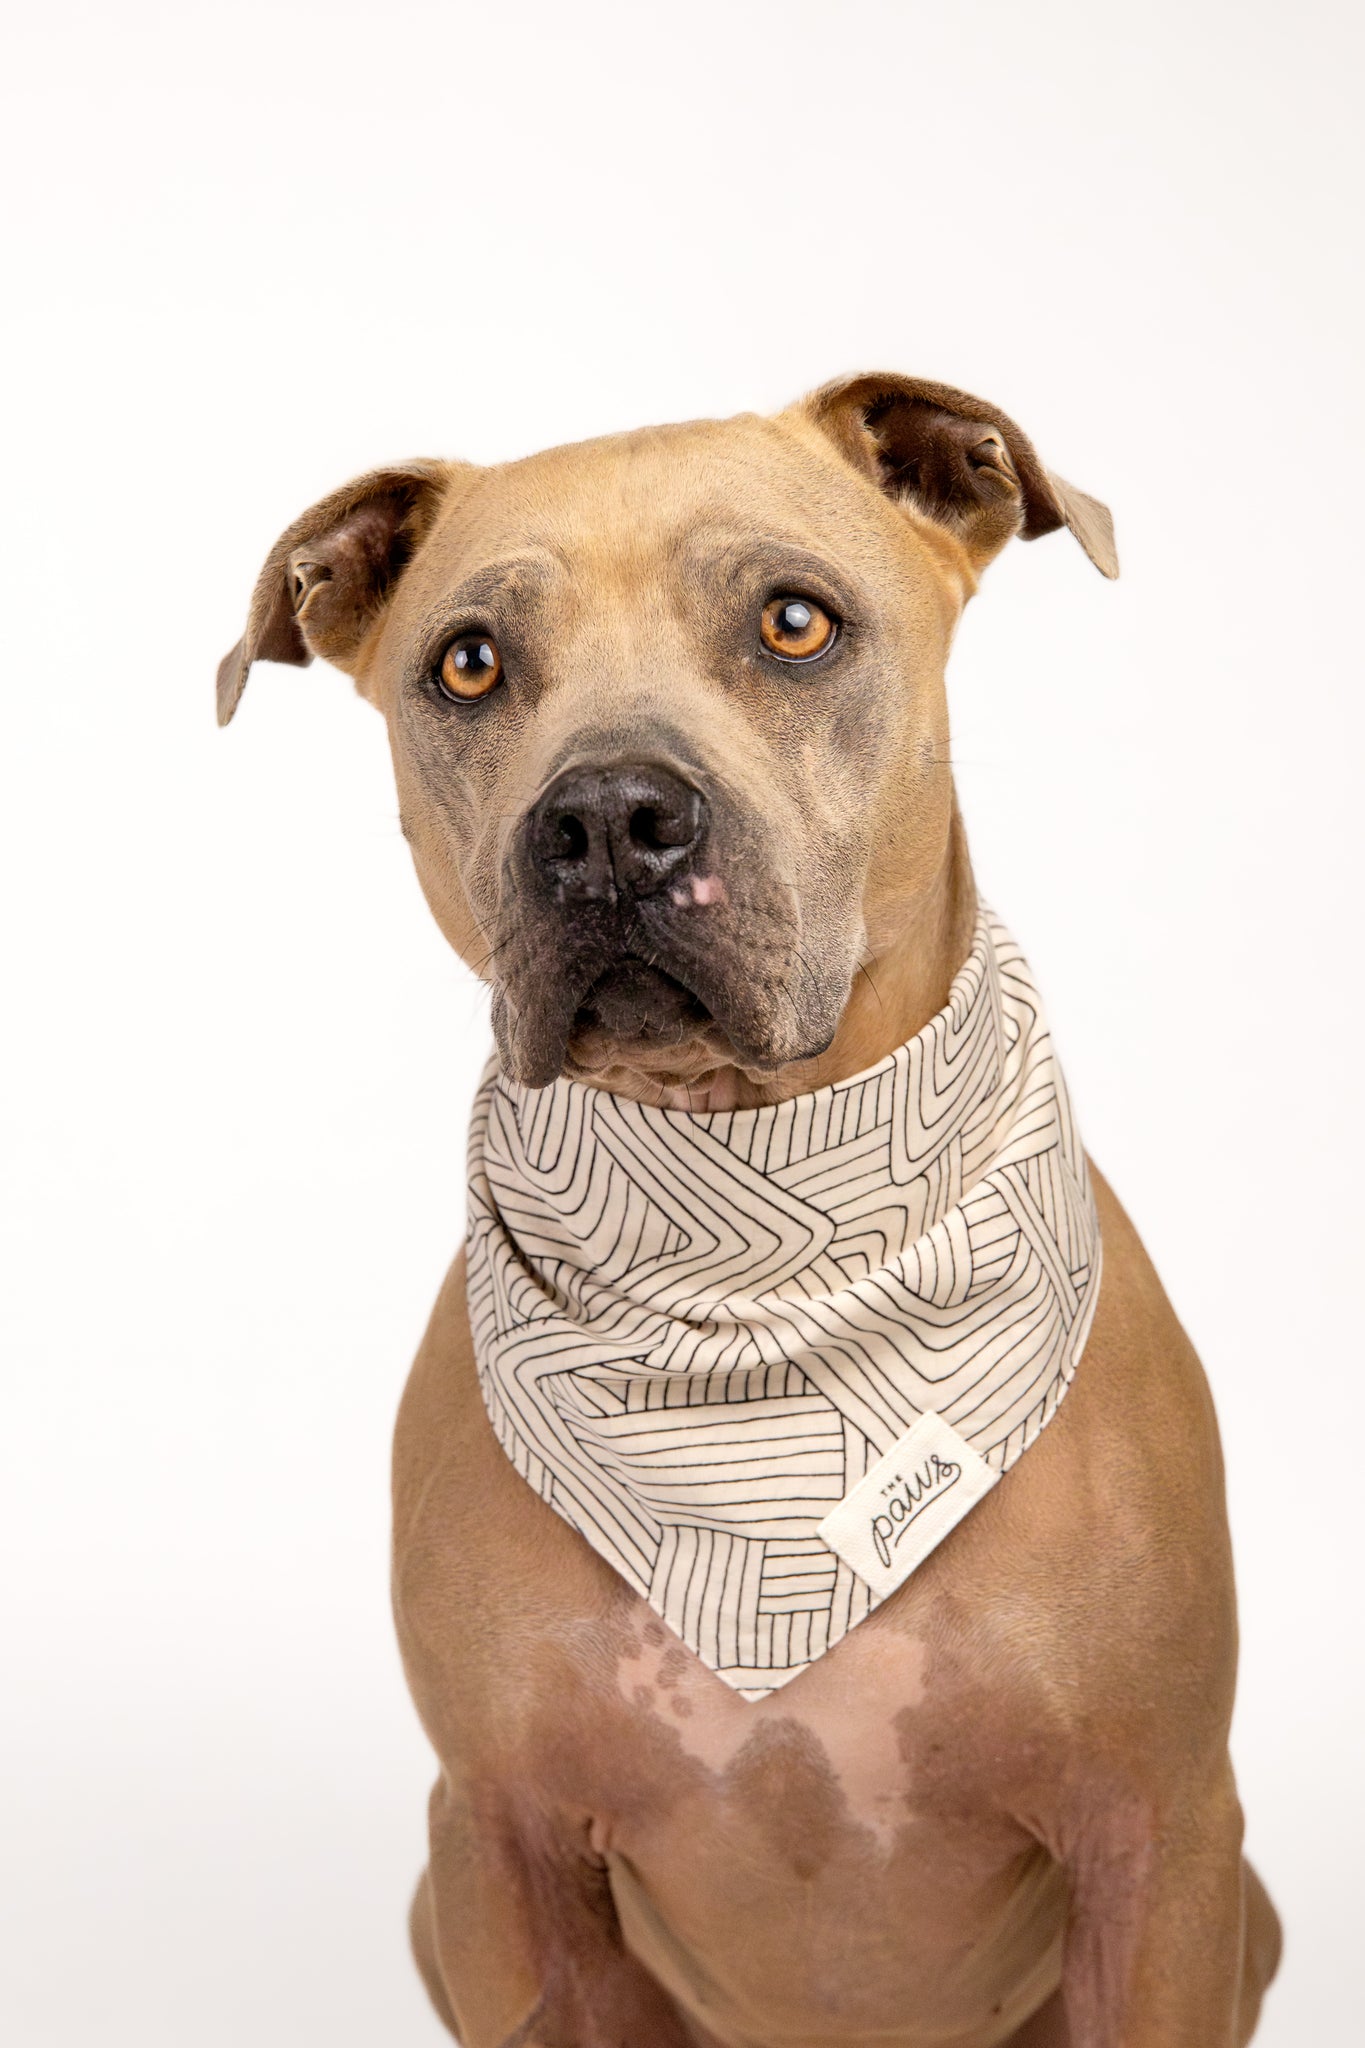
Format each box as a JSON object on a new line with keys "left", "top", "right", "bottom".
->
{"left": 469, "top": 911, "right": 1099, "bottom": 1700}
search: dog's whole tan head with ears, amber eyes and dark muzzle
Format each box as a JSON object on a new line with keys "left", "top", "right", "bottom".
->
{"left": 219, "top": 377, "right": 1117, "bottom": 1100}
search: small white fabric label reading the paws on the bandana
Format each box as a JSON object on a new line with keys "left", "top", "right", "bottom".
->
{"left": 819, "top": 1413, "right": 1001, "bottom": 1599}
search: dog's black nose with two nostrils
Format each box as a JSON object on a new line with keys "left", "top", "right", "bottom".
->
{"left": 530, "top": 764, "right": 706, "bottom": 901}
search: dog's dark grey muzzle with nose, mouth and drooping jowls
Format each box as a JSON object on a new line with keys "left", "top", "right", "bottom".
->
{"left": 493, "top": 741, "right": 849, "bottom": 1087}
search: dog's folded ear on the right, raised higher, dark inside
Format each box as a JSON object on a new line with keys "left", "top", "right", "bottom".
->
{"left": 798, "top": 375, "right": 1119, "bottom": 575}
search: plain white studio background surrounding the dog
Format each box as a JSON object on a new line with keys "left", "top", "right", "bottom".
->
{"left": 0, "top": 0, "right": 1365, "bottom": 2048}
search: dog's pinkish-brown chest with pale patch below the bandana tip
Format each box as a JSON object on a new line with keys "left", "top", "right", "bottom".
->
{"left": 523, "top": 1610, "right": 1066, "bottom": 2048}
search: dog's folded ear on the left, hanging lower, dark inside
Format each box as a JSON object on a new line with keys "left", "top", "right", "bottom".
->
{"left": 219, "top": 463, "right": 467, "bottom": 725}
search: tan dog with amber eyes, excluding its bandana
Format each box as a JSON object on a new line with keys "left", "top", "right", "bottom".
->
{"left": 219, "top": 377, "right": 1279, "bottom": 2048}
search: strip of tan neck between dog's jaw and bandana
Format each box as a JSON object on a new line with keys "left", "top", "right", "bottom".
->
{"left": 593, "top": 799, "right": 978, "bottom": 1112}
